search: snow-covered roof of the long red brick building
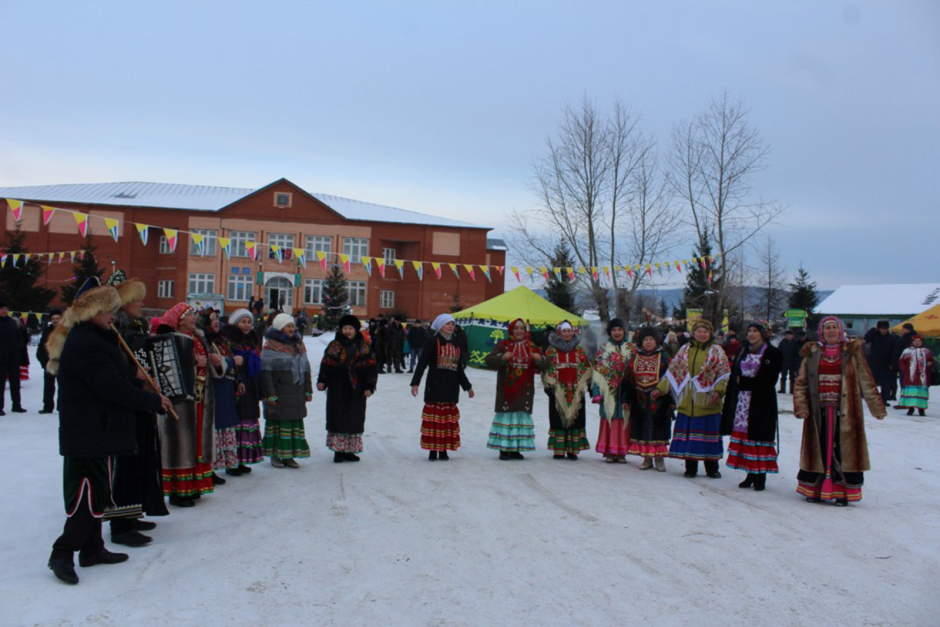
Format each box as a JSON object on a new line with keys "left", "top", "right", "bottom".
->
{"left": 0, "top": 181, "right": 489, "bottom": 229}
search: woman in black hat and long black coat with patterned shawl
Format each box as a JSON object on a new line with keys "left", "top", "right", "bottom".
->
{"left": 317, "top": 314, "right": 378, "bottom": 464}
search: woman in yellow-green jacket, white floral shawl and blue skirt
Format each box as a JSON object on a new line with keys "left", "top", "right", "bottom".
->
{"left": 651, "top": 318, "right": 731, "bottom": 479}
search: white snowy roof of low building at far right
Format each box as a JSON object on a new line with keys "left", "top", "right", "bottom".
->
{"left": 816, "top": 283, "right": 940, "bottom": 316}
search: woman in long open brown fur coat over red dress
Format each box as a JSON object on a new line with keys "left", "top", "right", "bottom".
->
{"left": 793, "top": 316, "right": 885, "bottom": 507}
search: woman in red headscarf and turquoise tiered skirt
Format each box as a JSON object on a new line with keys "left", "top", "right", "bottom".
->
{"left": 483, "top": 318, "right": 545, "bottom": 460}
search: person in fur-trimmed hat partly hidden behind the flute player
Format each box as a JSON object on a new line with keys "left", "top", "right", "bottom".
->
{"left": 108, "top": 271, "right": 169, "bottom": 546}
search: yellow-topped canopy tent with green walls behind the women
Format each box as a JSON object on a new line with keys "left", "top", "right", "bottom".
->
{"left": 454, "top": 285, "right": 588, "bottom": 368}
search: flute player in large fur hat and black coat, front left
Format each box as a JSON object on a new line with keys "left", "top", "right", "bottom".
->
{"left": 47, "top": 287, "right": 172, "bottom": 584}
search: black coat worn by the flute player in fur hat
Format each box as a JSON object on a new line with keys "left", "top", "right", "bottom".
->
{"left": 58, "top": 322, "right": 160, "bottom": 457}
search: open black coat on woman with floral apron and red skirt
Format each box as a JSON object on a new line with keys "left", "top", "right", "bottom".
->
{"left": 721, "top": 344, "right": 783, "bottom": 442}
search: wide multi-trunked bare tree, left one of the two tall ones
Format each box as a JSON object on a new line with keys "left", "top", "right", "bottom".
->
{"left": 510, "top": 97, "right": 675, "bottom": 322}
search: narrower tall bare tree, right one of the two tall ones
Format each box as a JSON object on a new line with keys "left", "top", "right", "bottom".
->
{"left": 669, "top": 93, "right": 784, "bottom": 322}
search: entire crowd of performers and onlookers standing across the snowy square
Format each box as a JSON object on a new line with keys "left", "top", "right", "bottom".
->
{"left": 0, "top": 280, "right": 936, "bottom": 584}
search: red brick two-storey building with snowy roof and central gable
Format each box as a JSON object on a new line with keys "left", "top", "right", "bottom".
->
{"left": 0, "top": 179, "right": 506, "bottom": 319}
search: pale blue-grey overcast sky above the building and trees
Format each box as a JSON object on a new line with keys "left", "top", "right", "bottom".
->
{"left": 0, "top": 0, "right": 940, "bottom": 289}
